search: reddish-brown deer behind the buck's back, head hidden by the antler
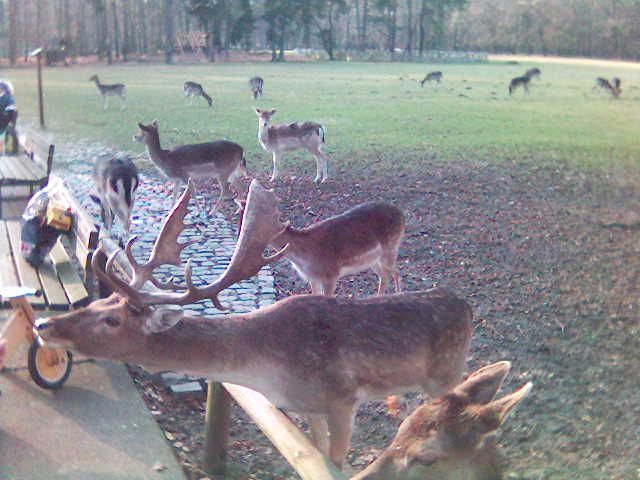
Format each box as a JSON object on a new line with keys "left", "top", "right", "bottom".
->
{"left": 240, "top": 192, "right": 405, "bottom": 296}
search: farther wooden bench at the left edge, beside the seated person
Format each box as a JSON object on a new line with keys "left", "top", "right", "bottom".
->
{"left": 0, "top": 132, "right": 55, "bottom": 217}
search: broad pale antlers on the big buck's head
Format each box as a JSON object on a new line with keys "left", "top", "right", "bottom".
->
{"left": 92, "top": 180, "right": 287, "bottom": 310}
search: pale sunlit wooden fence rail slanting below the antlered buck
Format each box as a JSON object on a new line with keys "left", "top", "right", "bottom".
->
{"left": 223, "top": 383, "right": 347, "bottom": 480}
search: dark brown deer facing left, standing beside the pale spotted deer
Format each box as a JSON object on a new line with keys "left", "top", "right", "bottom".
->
{"left": 133, "top": 120, "right": 247, "bottom": 213}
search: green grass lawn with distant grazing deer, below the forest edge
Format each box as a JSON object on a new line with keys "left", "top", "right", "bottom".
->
{"left": 1, "top": 62, "right": 640, "bottom": 171}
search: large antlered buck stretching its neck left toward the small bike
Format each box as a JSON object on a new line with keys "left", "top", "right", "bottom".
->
{"left": 35, "top": 180, "right": 473, "bottom": 467}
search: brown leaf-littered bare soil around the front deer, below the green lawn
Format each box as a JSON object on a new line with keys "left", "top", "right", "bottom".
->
{"left": 127, "top": 157, "right": 640, "bottom": 480}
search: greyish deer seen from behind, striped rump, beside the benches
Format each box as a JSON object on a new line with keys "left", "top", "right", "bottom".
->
{"left": 89, "top": 157, "right": 140, "bottom": 237}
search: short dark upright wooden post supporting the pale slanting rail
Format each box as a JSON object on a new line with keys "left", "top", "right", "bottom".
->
{"left": 204, "top": 382, "right": 231, "bottom": 475}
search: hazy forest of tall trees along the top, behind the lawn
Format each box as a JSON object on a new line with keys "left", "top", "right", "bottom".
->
{"left": 0, "top": 0, "right": 640, "bottom": 65}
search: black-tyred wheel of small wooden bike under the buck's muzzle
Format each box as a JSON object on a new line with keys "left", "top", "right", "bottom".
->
{"left": 27, "top": 340, "right": 73, "bottom": 390}
